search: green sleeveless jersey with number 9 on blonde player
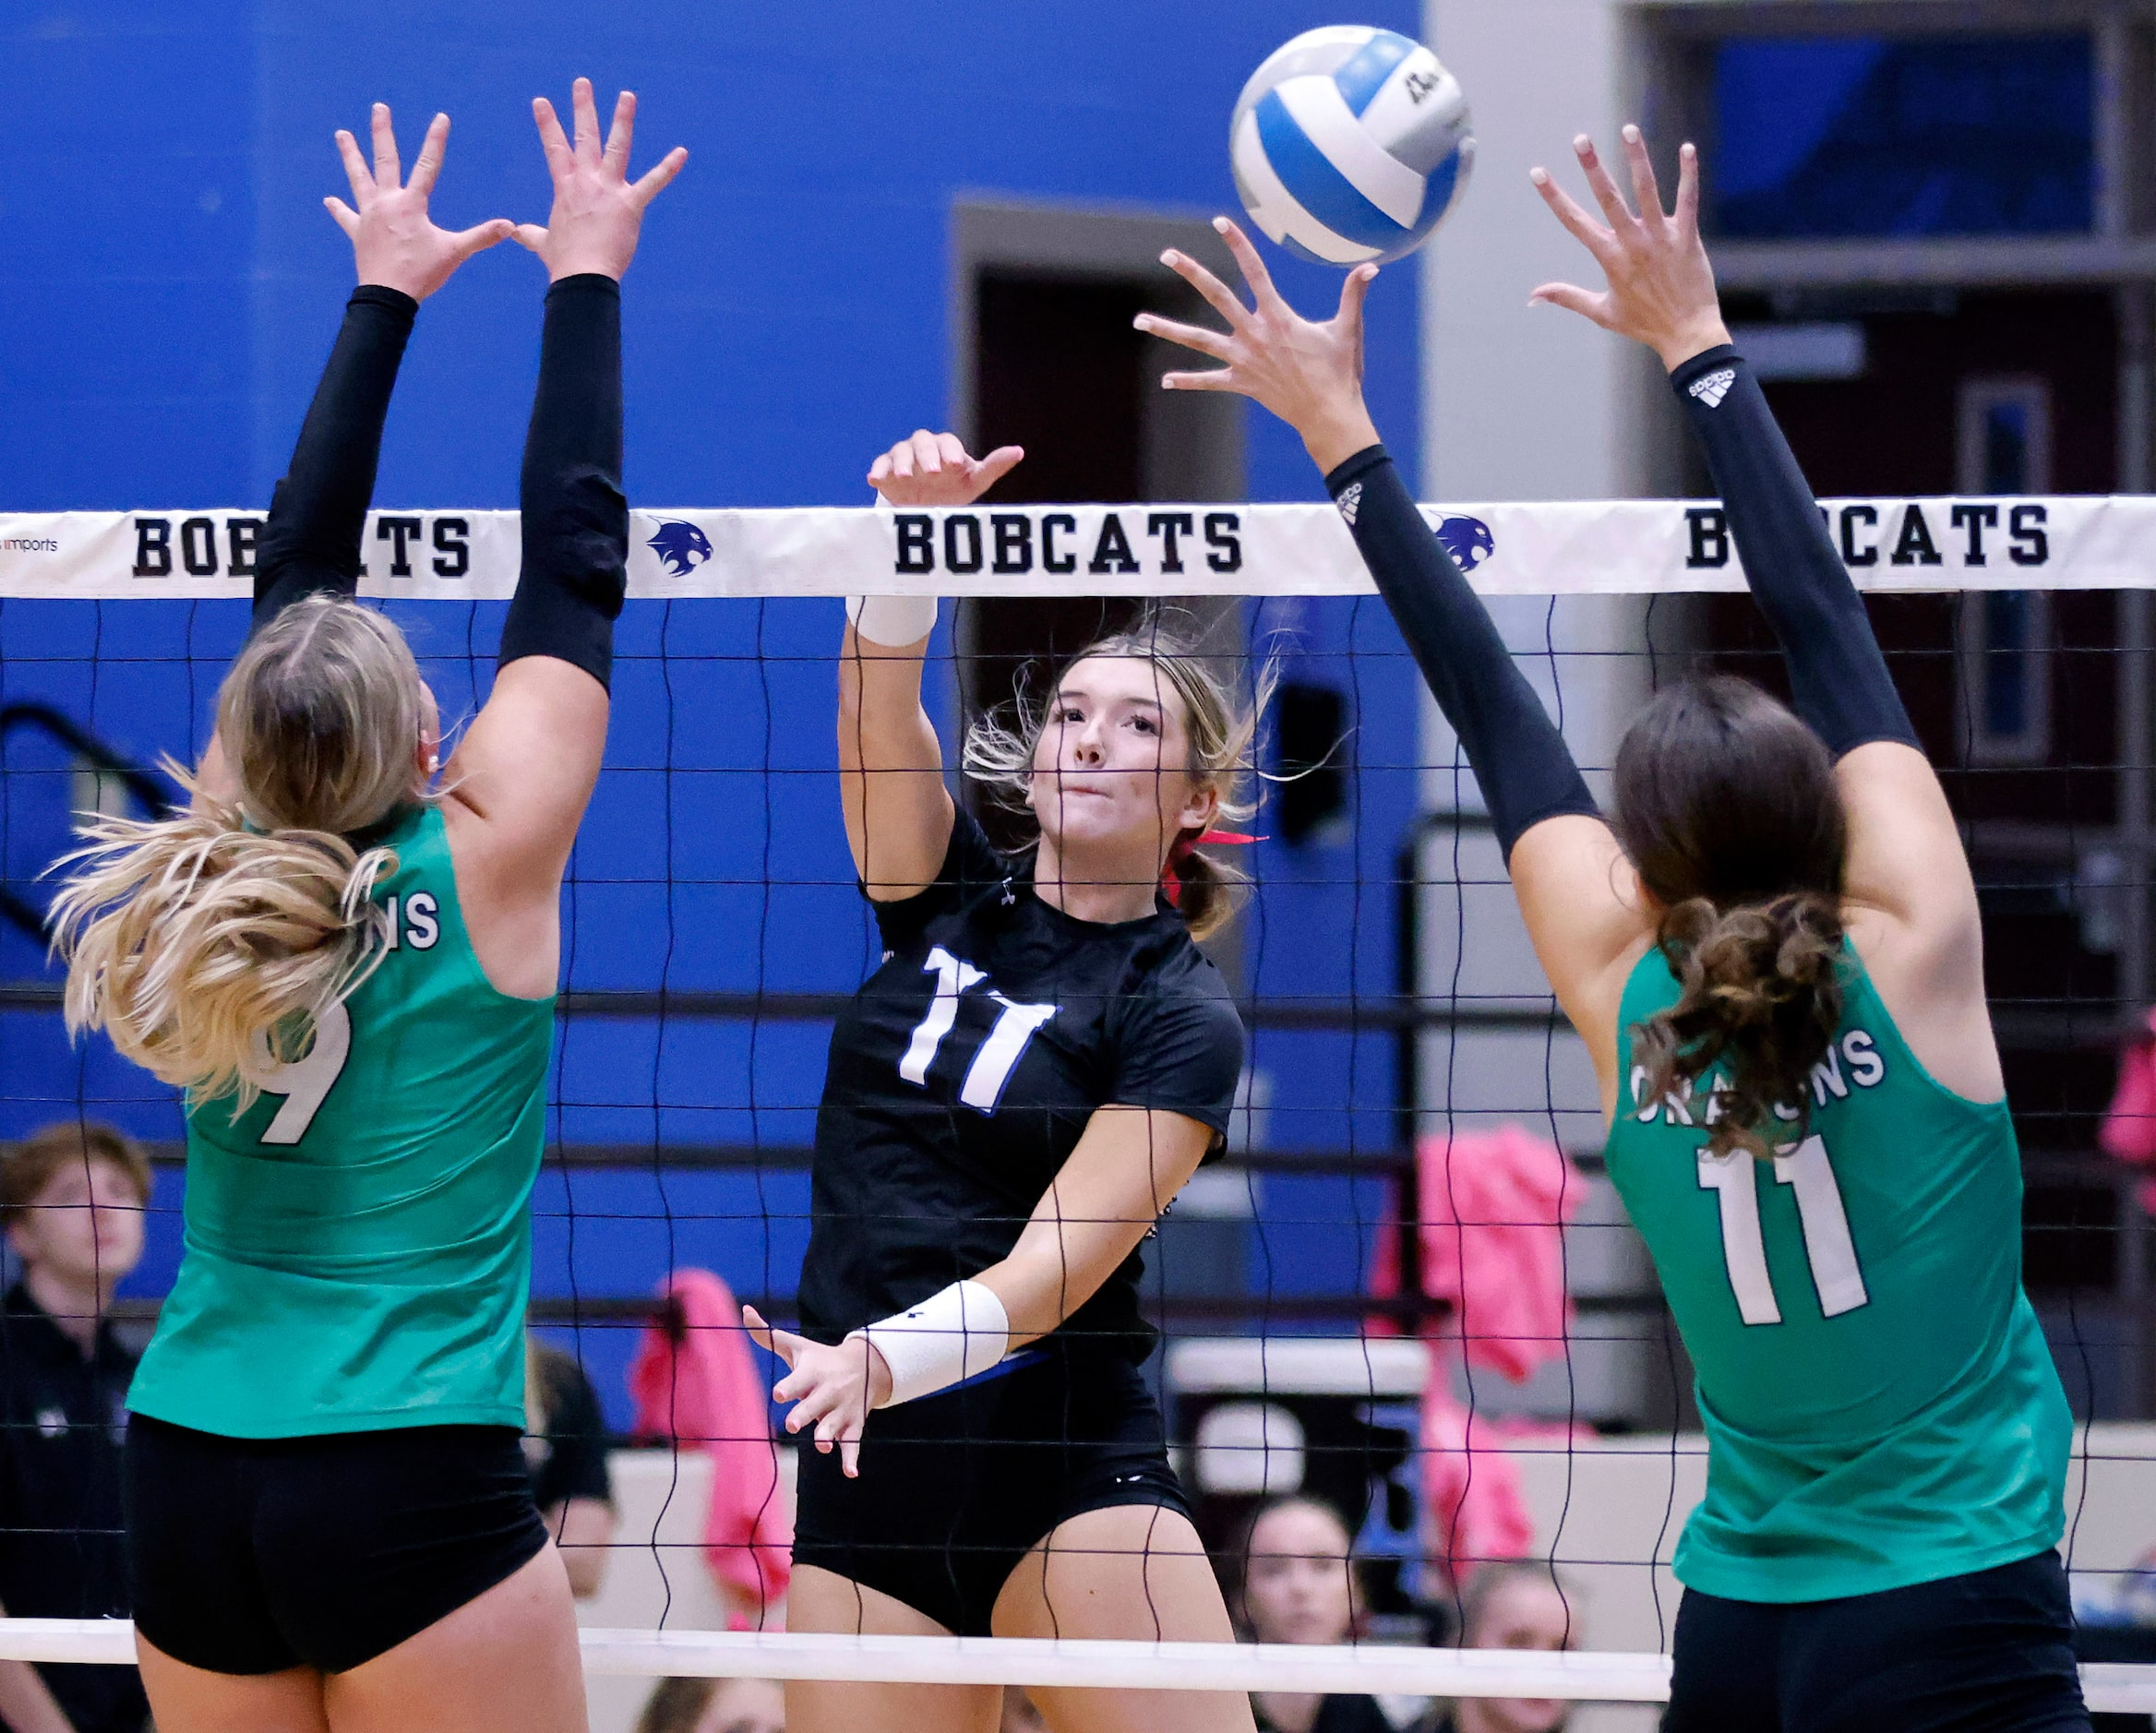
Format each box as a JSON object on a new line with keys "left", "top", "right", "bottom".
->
{"left": 127, "top": 808, "right": 554, "bottom": 1438}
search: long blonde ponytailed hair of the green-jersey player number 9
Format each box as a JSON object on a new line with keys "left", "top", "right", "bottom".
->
{"left": 52, "top": 597, "right": 427, "bottom": 1110}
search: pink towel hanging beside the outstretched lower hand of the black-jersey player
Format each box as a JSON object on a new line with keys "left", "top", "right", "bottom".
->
{"left": 629, "top": 1270, "right": 794, "bottom": 1630}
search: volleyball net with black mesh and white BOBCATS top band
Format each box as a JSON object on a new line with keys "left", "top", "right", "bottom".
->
{"left": 0, "top": 496, "right": 2156, "bottom": 1728}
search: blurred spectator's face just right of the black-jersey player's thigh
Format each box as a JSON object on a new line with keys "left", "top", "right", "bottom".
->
{"left": 1229, "top": 1498, "right": 1397, "bottom": 1733}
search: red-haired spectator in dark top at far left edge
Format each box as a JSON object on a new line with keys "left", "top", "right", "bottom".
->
{"left": 0, "top": 1123, "right": 151, "bottom": 1733}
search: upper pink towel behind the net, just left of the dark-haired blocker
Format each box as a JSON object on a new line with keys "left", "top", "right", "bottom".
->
{"left": 1371, "top": 1125, "right": 1585, "bottom": 1381}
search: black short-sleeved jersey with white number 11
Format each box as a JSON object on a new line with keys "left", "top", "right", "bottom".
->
{"left": 800, "top": 813, "right": 1242, "bottom": 1360}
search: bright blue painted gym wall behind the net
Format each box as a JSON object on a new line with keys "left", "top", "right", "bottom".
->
{"left": 0, "top": 0, "right": 1419, "bottom": 1418}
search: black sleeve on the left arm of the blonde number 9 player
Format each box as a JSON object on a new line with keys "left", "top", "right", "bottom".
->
{"left": 255, "top": 282, "right": 418, "bottom": 627}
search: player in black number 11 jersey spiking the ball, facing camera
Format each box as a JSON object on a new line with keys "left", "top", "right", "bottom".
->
{"left": 750, "top": 434, "right": 1251, "bottom": 1733}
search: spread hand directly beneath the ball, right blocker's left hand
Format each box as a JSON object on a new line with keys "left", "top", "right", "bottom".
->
{"left": 1134, "top": 218, "right": 1378, "bottom": 470}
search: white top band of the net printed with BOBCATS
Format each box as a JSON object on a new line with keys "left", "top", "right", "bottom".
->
{"left": 0, "top": 496, "right": 2129, "bottom": 602}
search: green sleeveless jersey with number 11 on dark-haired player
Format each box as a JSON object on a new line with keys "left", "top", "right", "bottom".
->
{"left": 1609, "top": 949, "right": 2072, "bottom": 1602}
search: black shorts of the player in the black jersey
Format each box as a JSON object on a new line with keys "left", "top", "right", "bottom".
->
{"left": 794, "top": 1339, "right": 1190, "bottom": 1636}
